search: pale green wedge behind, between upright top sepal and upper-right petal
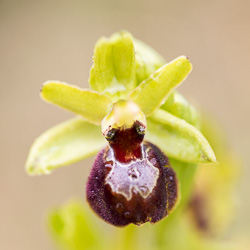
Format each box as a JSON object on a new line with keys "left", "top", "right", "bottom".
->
{"left": 133, "top": 38, "right": 166, "bottom": 84}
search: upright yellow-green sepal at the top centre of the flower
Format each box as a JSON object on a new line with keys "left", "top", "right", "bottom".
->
{"left": 89, "top": 32, "right": 136, "bottom": 101}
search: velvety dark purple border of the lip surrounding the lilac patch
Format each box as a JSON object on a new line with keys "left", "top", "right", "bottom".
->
{"left": 87, "top": 142, "right": 177, "bottom": 226}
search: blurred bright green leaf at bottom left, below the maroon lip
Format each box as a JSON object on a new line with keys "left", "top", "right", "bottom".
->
{"left": 48, "top": 201, "right": 106, "bottom": 250}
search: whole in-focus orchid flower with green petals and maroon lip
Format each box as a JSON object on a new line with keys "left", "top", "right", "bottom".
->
{"left": 26, "top": 32, "right": 216, "bottom": 226}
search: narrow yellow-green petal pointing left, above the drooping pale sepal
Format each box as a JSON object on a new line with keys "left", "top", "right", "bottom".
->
{"left": 41, "top": 81, "right": 112, "bottom": 125}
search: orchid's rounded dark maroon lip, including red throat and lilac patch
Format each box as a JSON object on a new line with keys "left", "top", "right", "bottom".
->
{"left": 87, "top": 121, "right": 177, "bottom": 226}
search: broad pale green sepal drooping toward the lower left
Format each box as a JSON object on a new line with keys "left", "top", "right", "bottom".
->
{"left": 26, "top": 117, "right": 107, "bottom": 175}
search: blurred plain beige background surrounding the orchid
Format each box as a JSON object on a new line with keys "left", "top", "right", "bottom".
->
{"left": 0, "top": 0, "right": 250, "bottom": 250}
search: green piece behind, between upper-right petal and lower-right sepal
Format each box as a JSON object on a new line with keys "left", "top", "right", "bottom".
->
{"left": 161, "top": 91, "right": 201, "bottom": 129}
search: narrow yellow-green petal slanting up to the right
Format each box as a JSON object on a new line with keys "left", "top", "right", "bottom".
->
{"left": 130, "top": 56, "right": 192, "bottom": 116}
